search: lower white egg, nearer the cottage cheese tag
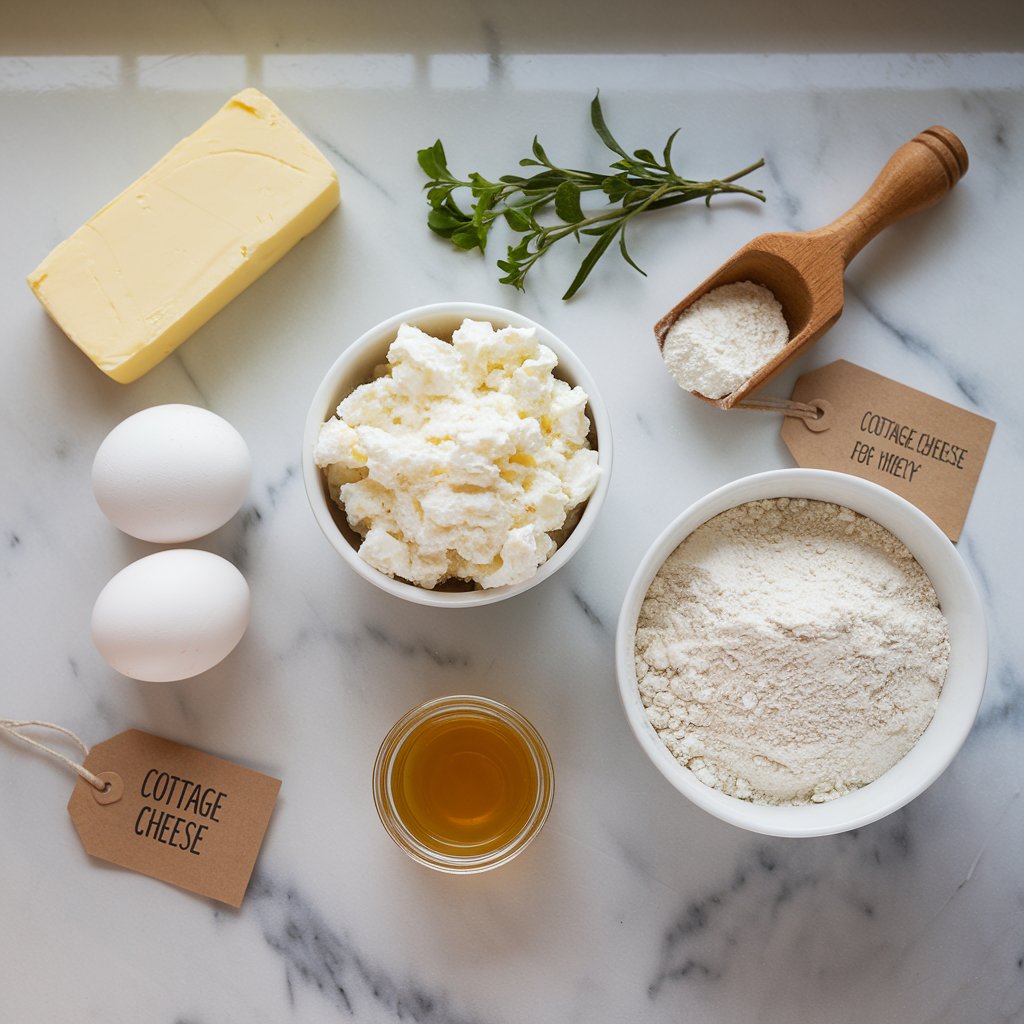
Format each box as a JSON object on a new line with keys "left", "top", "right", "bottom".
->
{"left": 92, "top": 549, "right": 249, "bottom": 682}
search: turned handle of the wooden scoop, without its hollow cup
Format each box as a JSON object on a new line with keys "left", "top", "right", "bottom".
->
{"left": 808, "top": 125, "right": 968, "bottom": 264}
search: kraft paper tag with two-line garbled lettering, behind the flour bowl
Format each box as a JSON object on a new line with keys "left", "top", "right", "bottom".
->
{"left": 782, "top": 359, "right": 995, "bottom": 541}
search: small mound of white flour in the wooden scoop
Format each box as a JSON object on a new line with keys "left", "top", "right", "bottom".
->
{"left": 662, "top": 281, "right": 790, "bottom": 398}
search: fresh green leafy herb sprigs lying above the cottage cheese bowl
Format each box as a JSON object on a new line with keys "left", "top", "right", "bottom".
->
{"left": 417, "top": 96, "right": 765, "bottom": 299}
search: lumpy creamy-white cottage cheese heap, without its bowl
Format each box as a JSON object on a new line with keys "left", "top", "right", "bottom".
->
{"left": 315, "top": 319, "right": 600, "bottom": 589}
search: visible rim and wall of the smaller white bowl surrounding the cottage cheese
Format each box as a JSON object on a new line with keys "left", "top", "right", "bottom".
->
{"left": 302, "top": 302, "right": 611, "bottom": 608}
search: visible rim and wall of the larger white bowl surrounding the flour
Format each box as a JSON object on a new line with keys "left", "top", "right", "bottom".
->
{"left": 615, "top": 469, "right": 988, "bottom": 836}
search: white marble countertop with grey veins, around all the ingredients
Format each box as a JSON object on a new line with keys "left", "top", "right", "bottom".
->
{"left": 0, "top": 8, "right": 1024, "bottom": 1024}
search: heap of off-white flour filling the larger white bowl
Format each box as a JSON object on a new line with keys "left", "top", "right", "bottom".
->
{"left": 635, "top": 498, "right": 949, "bottom": 804}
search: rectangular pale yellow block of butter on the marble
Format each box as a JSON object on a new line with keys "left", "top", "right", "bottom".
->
{"left": 29, "top": 89, "right": 338, "bottom": 384}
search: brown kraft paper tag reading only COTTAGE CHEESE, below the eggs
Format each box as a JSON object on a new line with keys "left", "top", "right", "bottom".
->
{"left": 68, "top": 729, "right": 281, "bottom": 906}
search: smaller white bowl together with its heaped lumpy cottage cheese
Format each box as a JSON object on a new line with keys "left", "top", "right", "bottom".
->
{"left": 302, "top": 302, "right": 611, "bottom": 607}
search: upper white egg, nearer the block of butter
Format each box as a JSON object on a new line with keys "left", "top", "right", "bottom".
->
{"left": 92, "top": 406, "right": 252, "bottom": 544}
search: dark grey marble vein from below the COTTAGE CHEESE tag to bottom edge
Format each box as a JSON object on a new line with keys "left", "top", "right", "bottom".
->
{"left": 247, "top": 872, "right": 480, "bottom": 1024}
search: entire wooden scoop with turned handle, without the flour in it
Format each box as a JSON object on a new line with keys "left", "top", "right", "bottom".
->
{"left": 654, "top": 125, "right": 968, "bottom": 409}
